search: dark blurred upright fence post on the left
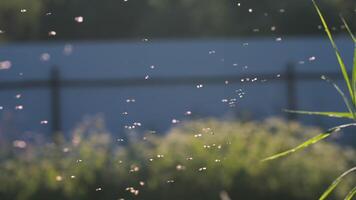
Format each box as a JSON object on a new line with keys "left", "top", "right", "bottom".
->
{"left": 50, "top": 66, "right": 62, "bottom": 143}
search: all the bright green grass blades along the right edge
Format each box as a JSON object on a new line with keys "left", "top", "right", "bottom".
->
{"left": 262, "top": 0, "right": 356, "bottom": 200}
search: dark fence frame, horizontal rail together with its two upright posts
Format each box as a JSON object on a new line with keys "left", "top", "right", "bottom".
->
{"left": 0, "top": 65, "right": 348, "bottom": 138}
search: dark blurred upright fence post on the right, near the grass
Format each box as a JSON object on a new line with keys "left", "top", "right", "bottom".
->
{"left": 286, "top": 63, "right": 298, "bottom": 120}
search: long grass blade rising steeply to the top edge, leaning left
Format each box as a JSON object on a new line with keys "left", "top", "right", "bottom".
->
{"left": 312, "top": 0, "right": 355, "bottom": 105}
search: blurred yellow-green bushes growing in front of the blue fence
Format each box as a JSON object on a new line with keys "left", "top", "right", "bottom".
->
{"left": 0, "top": 118, "right": 356, "bottom": 200}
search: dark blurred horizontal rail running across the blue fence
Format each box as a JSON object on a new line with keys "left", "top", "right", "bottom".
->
{"left": 0, "top": 72, "right": 348, "bottom": 90}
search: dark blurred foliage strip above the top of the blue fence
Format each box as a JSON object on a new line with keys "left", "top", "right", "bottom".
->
{"left": 0, "top": 0, "right": 356, "bottom": 40}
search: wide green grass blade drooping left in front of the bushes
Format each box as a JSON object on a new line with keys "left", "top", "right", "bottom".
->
{"left": 261, "top": 123, "right": 356, "bottom": 162}
